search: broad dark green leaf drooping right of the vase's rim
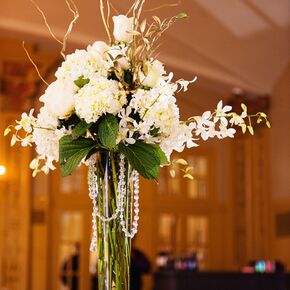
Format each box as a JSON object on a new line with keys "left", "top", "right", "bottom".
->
{"left": 119, "top": 141, "right": 162, "bottom": 179}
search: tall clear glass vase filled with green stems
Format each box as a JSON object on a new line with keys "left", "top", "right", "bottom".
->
{"left": 89, "top": 151, "right": 133, "bottom": 290}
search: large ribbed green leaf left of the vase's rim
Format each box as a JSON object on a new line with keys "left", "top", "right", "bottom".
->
{"left": 59, "top": 136, "right": 96, "bottom": 176}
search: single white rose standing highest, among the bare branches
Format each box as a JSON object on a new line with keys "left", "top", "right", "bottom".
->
{"left": 113, "top": 15, "right": 133, "bottom": 42}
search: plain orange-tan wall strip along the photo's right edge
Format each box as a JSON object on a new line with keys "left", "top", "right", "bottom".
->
{"left": 270, "top": 64, "right": 290, "bottom": 269}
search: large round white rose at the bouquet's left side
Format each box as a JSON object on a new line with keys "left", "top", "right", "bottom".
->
{"left": 39, "top": 80, "right": 77, "bottom": 118}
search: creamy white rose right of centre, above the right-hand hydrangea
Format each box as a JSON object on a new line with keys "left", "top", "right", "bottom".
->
{"left": 139, "top": 60, "right": 165, "bottom": 88}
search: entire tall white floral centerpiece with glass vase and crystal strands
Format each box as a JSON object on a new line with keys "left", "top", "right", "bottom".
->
{"left": 4, "top": 0, "right": 269, "bottom": 290}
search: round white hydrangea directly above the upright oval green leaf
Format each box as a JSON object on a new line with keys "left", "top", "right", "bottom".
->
{"left": 75, "top": 77, "right": 127, "bottom": 123}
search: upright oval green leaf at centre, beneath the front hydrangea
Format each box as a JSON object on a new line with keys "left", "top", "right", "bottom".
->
{"left": 98, "top": 114, "right": 119, "bottom": 149}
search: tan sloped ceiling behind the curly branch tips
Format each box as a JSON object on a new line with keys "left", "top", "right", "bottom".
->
{"left": 0, "top": 0, "right": 290, "bottom": 94}
